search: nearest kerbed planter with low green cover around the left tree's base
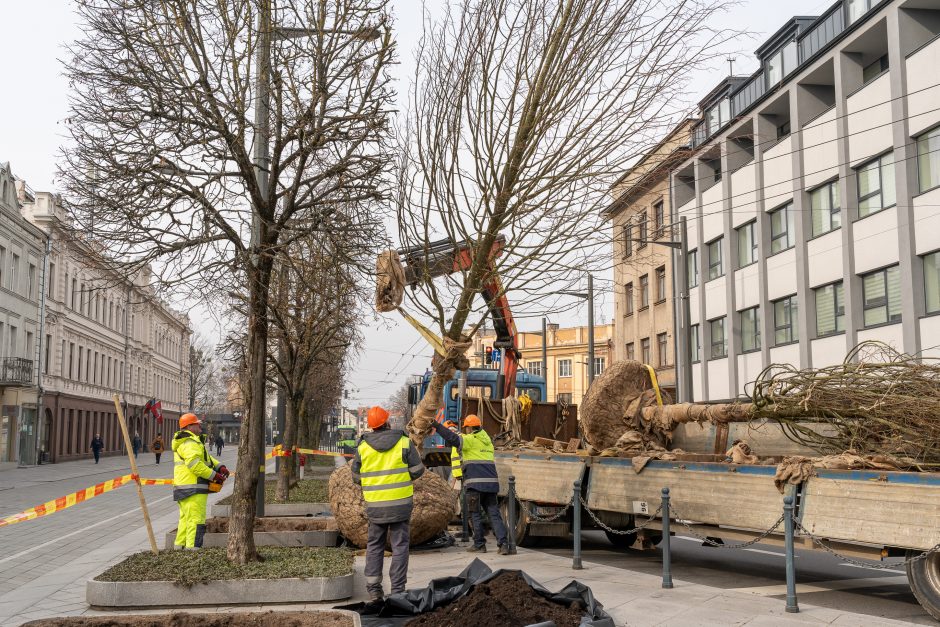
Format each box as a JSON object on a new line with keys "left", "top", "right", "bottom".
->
{"left": 86, "top": 547, "right": 354, "bottom": 608}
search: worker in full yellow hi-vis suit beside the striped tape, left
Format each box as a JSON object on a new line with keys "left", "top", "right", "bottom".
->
{"left": 171, "top": 414, "right": 229, "bottom": 549}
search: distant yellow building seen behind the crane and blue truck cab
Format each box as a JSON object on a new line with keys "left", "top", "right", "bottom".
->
{"left": 467, "top": 324, "right": 614, "bottom": 405}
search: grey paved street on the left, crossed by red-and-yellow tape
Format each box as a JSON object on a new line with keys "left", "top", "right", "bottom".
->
{"left": 0, "top": 447, "right": 246, "bottom": 625}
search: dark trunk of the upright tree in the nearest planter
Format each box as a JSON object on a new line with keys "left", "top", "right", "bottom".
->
{"left": 227, "top": 256, "right": 271, "bottom": 564}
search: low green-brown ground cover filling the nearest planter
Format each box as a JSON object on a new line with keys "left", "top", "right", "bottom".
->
{"left": 95, "top": 547, "right": 354, "bottom": 586}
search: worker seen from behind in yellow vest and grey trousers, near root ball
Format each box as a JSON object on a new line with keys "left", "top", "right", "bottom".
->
{"left": 352, "top": 407, "right": 424, "bottom": 602}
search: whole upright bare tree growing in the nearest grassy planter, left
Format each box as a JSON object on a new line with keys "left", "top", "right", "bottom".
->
{"left": 60, "top": 0, "right": 393, "bottom": 562}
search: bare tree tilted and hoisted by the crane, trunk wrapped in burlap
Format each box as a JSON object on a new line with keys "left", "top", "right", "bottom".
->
{"left": 397, "top": 0, "right": 727, "bottom": 438}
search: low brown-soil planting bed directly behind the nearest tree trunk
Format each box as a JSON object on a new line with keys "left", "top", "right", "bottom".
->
{"left": 164, "top": 516, "right": 339, "bottom": 550}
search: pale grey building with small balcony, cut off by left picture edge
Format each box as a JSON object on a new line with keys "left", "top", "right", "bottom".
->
{"left": 0, "top": 163, "right": 46, "bottom": 467}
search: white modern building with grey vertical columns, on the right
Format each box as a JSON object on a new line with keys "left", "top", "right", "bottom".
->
{"left": 671, "top": 0, "right": 940, "bottom": 400}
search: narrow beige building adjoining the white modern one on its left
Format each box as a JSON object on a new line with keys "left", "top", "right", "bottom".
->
{"left": 606, "top": 120, "right": 693, "bottom": 388}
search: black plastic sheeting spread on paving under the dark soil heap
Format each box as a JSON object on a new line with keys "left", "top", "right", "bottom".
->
{"left": 334, "top": 559, "right": 614, "bottom": 627}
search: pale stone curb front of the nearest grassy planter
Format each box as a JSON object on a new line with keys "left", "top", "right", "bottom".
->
{"left": 85, "top": 573, "right": 353, "bottom": 608}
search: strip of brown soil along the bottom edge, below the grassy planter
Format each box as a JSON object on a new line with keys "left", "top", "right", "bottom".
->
{"left": 24, "top": 611, "right": 354, "bottom": 627}
